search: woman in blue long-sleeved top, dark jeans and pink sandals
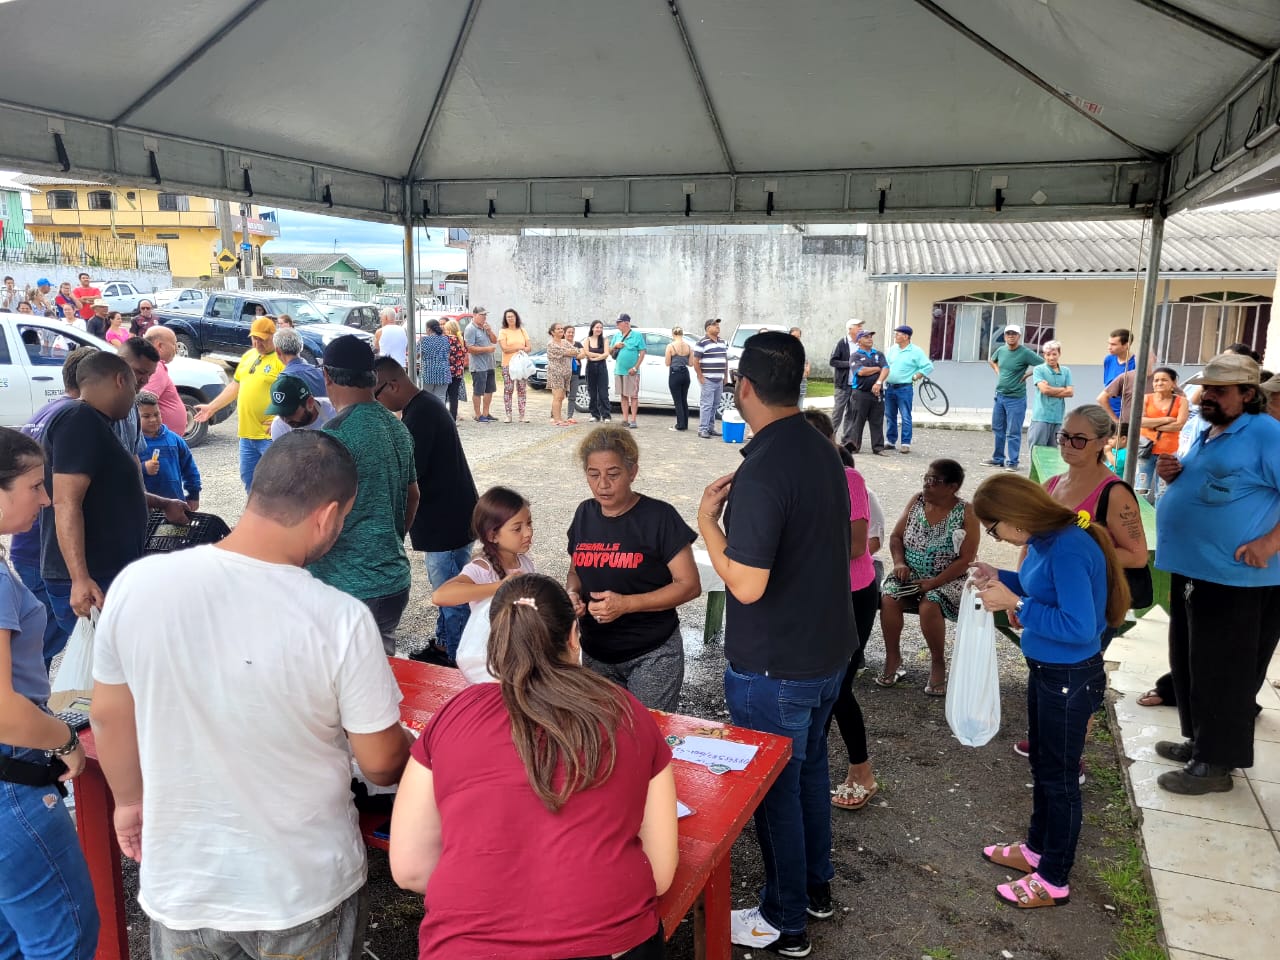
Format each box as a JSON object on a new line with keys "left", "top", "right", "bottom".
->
{"left": 973, "top": 474, "right": 1129, "bottom": 909}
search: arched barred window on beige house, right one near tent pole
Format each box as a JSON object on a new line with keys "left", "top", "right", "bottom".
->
{"left": 1156, "top": 292, "right": 1271, "bottom": 366}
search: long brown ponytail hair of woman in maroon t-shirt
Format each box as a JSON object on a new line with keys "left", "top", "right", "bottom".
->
{"left": 488, "top": 573, "right": 631, "bottom": 813}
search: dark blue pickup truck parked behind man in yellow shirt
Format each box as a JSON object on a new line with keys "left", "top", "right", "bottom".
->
{"left": 159, "top": 292, "right": 374, "bottom": 364}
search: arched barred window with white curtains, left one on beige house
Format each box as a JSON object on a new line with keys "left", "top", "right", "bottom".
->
{"left": 929, "top": 293, "right": 1057, "bottom": 362}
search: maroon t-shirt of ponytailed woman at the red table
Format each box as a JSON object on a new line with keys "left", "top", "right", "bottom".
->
{"left": 411, "top": 684, "right": 671, "bottom": 960}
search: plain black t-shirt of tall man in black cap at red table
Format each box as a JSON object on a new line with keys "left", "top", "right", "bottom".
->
{"left": 724, "top": 413, "right": 858, "bottom": 680}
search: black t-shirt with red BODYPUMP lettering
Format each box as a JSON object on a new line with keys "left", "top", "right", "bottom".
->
{"left": 568, "top": 494, "right": 698, "bottom": 663}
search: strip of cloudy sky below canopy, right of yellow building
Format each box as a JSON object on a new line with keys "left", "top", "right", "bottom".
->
{"left": 272, "top": 209, "right": 467, "bottom": 273}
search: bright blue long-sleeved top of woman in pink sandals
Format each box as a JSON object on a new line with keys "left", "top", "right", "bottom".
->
{"left": 1000, "top": 527, "right": 1105, "bottom": 663}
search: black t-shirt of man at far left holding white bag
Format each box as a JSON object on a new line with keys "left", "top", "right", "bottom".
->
{"left": 40, "top": 401, "right": 147, "bottom": 585}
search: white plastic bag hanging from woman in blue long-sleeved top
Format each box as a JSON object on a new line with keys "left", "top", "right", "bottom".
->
{"left": 946, "top": 582, "right": 1000, "bottom": 746}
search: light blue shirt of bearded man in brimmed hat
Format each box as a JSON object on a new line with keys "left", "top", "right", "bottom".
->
{"left": 1156, "top": 413, "right": 1280, "bottom": 586}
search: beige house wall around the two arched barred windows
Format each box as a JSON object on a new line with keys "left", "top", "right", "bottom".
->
{"left": 884, "top": 279, "right": 1280, "bottom": 408}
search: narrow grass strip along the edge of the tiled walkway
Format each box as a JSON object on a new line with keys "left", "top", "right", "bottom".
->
{"left": 1089, "top": 712, "right": 1169, "bottom": 960}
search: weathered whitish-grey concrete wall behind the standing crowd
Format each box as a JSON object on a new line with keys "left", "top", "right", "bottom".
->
{"left": 468, "top": 232, "right": 884, "bottom": 375}
